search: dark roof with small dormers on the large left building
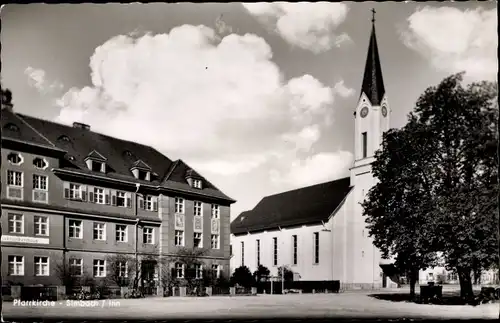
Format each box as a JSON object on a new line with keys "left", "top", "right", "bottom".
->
{"left": 1, "top": 109, "right": 234, "bottom": 202}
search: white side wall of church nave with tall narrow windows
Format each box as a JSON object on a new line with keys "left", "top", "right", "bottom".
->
{"left": 231, "top": 224, "right": 333, "bottom": 280}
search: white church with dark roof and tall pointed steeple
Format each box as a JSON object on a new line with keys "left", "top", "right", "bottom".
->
{"left": 231, "top": 15, "right": 395, "bottom": 289}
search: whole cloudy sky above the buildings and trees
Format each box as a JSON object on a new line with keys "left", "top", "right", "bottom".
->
{"left": 1, "top": 1, "right": 498, "bottom": 219}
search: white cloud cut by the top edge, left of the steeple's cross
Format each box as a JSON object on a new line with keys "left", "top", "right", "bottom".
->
{"left": 243, "top": 2, "right": 351, "bottom": 53}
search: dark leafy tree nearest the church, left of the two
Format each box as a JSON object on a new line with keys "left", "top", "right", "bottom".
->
{"left": 362, "top": 117, "right": 436, "bottom": 299}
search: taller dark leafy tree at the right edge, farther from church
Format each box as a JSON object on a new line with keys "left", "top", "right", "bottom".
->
{"left": 415, "top": 73, "right": 499, "bottom": 299}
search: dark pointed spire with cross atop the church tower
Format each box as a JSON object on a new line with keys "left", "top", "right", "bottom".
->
{"left": 361, "top": 9, "right": 385, "bottom": 105}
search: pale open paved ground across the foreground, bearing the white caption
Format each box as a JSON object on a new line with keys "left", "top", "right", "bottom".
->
{"left": 4, "top": 292, "right": 499, "bottom": 320}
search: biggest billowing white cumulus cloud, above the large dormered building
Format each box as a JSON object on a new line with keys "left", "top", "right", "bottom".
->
{"left": 54, "top": 25, "right": 348, "bottom": 182}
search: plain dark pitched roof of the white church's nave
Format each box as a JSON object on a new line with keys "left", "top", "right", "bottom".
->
{"left": 231, "top": 177, "right": 351, "bottom": 234}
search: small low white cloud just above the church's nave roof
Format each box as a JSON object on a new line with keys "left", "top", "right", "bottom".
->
{"left": 269, "top": 150, "right": 353, "bottom": 187}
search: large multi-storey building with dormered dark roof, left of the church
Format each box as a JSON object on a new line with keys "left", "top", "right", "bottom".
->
{"left": 0, "top": 97, "right": 234, "bottom": 292}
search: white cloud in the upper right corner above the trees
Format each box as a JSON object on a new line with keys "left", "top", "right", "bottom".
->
{"left": 402, "top": 7, "right": 498, "bottom": 80}
